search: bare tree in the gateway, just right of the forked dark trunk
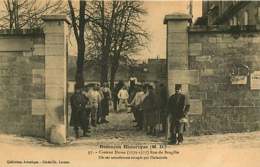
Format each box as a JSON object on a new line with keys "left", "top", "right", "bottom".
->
{"left": 87, "top": 1, "right": 120, "bottom": 83}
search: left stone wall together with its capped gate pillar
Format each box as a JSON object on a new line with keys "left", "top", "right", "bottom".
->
{"left": 0, "top": 15, "right": 69, "bottom": 142}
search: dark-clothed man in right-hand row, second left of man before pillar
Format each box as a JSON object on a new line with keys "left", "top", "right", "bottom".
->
{"left": 143, "top": 85, "right": 158, "bottom": 135}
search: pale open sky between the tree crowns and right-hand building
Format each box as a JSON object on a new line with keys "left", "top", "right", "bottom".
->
{"left": 139, "top": 0, "right": 202, "bottom": 60}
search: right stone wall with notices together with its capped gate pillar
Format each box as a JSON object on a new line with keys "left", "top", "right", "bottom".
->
{"left": 165, "top": 14, "right": 260, "bottom": 135}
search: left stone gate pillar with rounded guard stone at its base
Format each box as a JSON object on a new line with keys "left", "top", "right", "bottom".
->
{"left": 42, "top": 15, "right": 70, "bottom": 144}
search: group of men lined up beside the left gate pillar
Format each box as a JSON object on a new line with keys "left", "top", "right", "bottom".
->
{"left": 70, "top": 83, "right": 111, "bottom": 138}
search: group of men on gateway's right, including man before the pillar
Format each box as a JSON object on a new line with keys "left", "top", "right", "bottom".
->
{"left": 125, "top": 80, "right": 190, "bottom": 144}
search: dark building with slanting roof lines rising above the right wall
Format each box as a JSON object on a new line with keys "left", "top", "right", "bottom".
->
{"left": 195, "top": 0, "right": 260, "bottom": 26}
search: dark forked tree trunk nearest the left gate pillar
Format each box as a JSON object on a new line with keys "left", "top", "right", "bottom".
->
{"left": 68, "top": 0, "right": 86, "bottom": 87}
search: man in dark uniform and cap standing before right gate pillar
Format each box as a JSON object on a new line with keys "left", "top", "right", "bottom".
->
{"left": 167, "top": 84, "right": 190, "bottom": 144}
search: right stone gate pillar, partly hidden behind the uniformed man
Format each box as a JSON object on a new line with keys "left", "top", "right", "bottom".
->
{"left": 164, "top": 13, "right": 191, "bottom": 139}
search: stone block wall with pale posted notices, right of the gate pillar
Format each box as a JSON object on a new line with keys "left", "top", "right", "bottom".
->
{"left": 189, "top": 27, "right": 260, "bottom": 134}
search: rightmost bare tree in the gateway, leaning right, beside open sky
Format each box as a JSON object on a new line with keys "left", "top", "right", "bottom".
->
{"left": 110, "top": 1, "right": 149, "bottom": 87}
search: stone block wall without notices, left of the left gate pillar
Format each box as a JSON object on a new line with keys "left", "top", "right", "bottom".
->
{"left": 0, "top": 30, "right": 45, "bottom": 136}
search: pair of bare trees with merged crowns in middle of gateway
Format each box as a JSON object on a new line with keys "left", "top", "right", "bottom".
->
{"left": 87, "top": 1, "right": 148, "bottom": 86}
